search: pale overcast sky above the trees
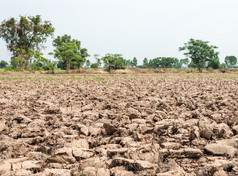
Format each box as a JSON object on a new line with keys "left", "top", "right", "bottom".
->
{"left": 0, "top": 0, "right": 238, "bottom": 64}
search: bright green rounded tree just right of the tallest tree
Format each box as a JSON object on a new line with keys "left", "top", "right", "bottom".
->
{"left": 50, "top": 35, "right": 89, "bottom": 73}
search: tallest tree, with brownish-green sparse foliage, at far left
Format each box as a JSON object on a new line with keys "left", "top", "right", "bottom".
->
{"left": 0, "top": 15, "right": 55, "bottom": 67}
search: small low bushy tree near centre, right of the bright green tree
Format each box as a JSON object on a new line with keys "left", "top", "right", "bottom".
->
{"left": 102, "top": 54, "right": 126, "bottom": 72}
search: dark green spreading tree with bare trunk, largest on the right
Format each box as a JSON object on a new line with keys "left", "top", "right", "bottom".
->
{"left": 179, "top": 39, "right": 219, "bottom": 73}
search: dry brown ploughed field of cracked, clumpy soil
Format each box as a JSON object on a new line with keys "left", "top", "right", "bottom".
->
{"left": 0, "top": 74, "right": 238, "bottom": 176}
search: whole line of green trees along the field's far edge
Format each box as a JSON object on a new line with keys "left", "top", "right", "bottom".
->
{"left": 0, "top": 15, "right": 237, "bottom": 73}
